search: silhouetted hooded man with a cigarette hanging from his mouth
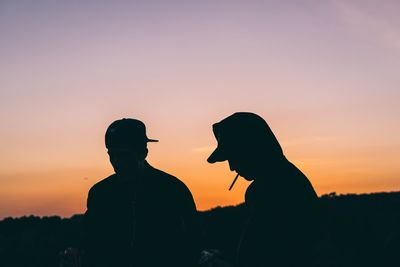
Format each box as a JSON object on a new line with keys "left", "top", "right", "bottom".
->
{"left": 208, "top": 112, "right": 319, "bottom": 267}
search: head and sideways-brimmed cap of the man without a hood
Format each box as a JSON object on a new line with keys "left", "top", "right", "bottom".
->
{"left": 105, "top": 118, "right": 158, "bottom": 174}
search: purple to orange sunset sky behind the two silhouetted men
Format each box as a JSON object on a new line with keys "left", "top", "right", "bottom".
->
{"left": 0, "top": 0, "right": 400, "bottom": 218}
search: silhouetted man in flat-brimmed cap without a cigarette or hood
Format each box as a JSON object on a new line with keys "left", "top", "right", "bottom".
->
{"left": 85, "top": 119, "right": 198, "bottom": 267}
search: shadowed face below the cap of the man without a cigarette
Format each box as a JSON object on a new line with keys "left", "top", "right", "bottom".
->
{"left": 107, "top": 148, "right": 143, "bottom": 175}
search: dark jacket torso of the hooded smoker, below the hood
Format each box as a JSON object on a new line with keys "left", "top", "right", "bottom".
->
{"left": 237, "top": 159, "right": 320, "bottom": 267}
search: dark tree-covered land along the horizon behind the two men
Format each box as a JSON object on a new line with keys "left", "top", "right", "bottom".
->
{"left": 0, "top": 192, "right": 400, "bottom": 267}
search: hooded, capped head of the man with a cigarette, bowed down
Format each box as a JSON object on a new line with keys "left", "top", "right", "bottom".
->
{"left": 207, "top": 112, "right": 283, "bottom": 180}
